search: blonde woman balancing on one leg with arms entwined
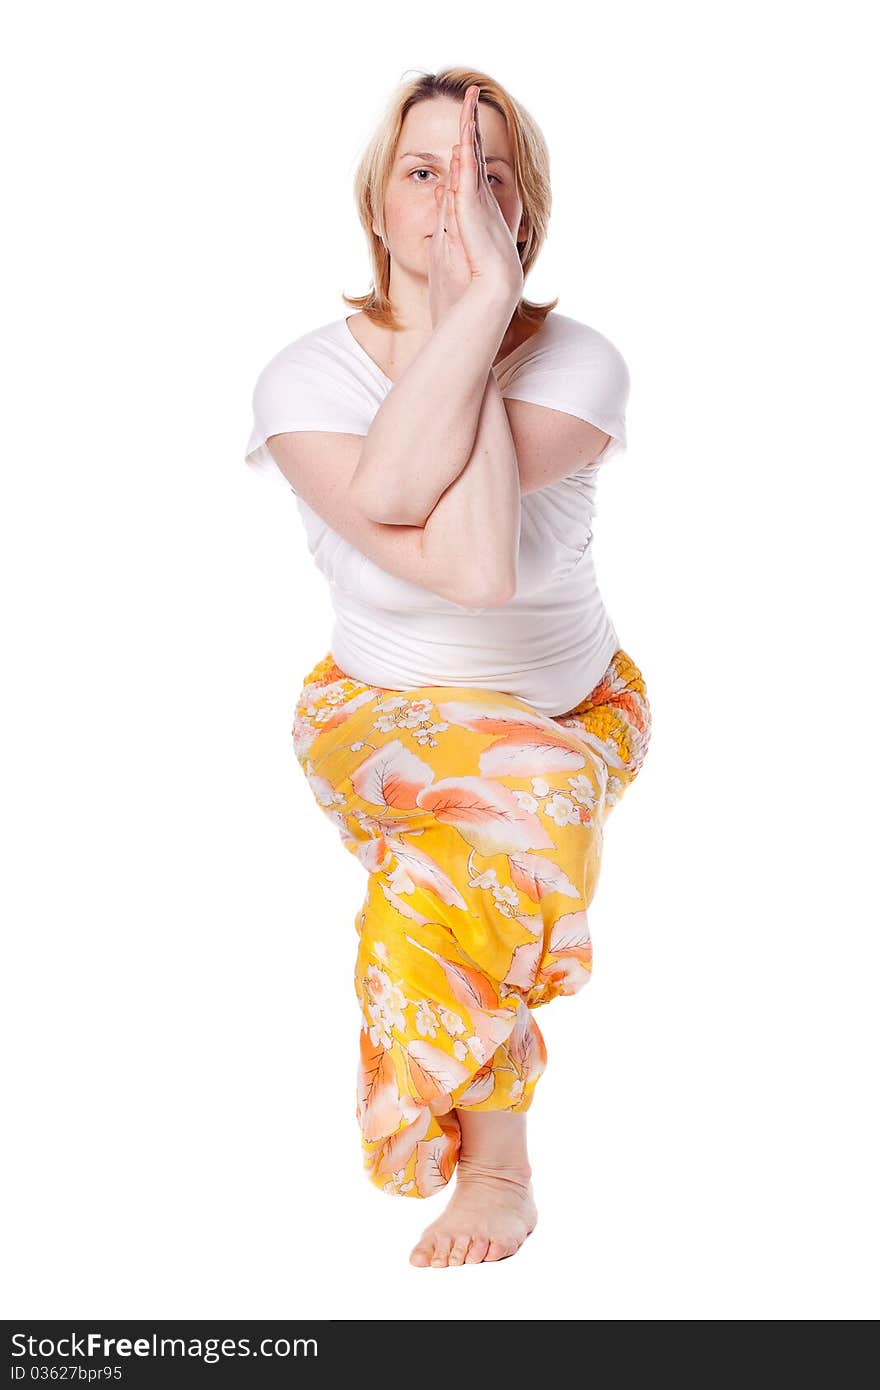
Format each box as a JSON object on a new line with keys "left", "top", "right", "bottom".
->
{"left": 247, "top": 68, "right": 651, "bottom": 1268}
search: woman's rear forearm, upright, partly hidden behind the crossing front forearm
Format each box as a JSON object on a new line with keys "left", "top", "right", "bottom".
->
{"left": 423, "top": 373, "right": 521, "bottom": 607}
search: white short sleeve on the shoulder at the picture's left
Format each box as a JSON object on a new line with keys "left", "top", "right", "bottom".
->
{"left": 245, "top": 341, "right": 368, "bottom": 492}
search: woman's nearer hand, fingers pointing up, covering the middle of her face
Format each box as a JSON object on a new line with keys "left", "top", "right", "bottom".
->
{"left": 446, "top": 83, "right": 523, "bottom": 299}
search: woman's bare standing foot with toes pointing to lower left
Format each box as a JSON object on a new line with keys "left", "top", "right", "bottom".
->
{"left": 410, "top": 1158, "right": 538, "bottom": 1269}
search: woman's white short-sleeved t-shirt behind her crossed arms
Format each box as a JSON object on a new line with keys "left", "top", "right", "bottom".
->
{"left": 246, "top": 310, "right": 630, "bottom": 714}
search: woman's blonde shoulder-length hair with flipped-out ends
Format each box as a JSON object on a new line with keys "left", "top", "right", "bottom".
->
{"left": 342, "top": 68, "right": 559, "bottom": 329}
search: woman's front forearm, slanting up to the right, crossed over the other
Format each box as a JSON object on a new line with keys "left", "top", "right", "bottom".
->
{"left": 352, "top": 281, "right": 519, "bottom": 525}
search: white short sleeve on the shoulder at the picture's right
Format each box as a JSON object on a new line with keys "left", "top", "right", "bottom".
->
{"left": 502, "top": 318, "right": 630, "bottom": 467}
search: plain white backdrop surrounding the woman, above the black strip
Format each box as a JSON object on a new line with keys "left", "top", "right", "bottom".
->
{"left": 0, "top": 0, "right": 880, "bottom": 1322}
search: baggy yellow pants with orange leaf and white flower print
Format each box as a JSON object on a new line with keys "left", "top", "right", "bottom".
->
{"left": 292, "top": 649, "right": 651, "bottom": 1197}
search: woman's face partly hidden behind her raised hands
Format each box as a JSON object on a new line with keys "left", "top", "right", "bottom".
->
{"left": 373, "top": 96, "right": 524, "bottom": 275}
